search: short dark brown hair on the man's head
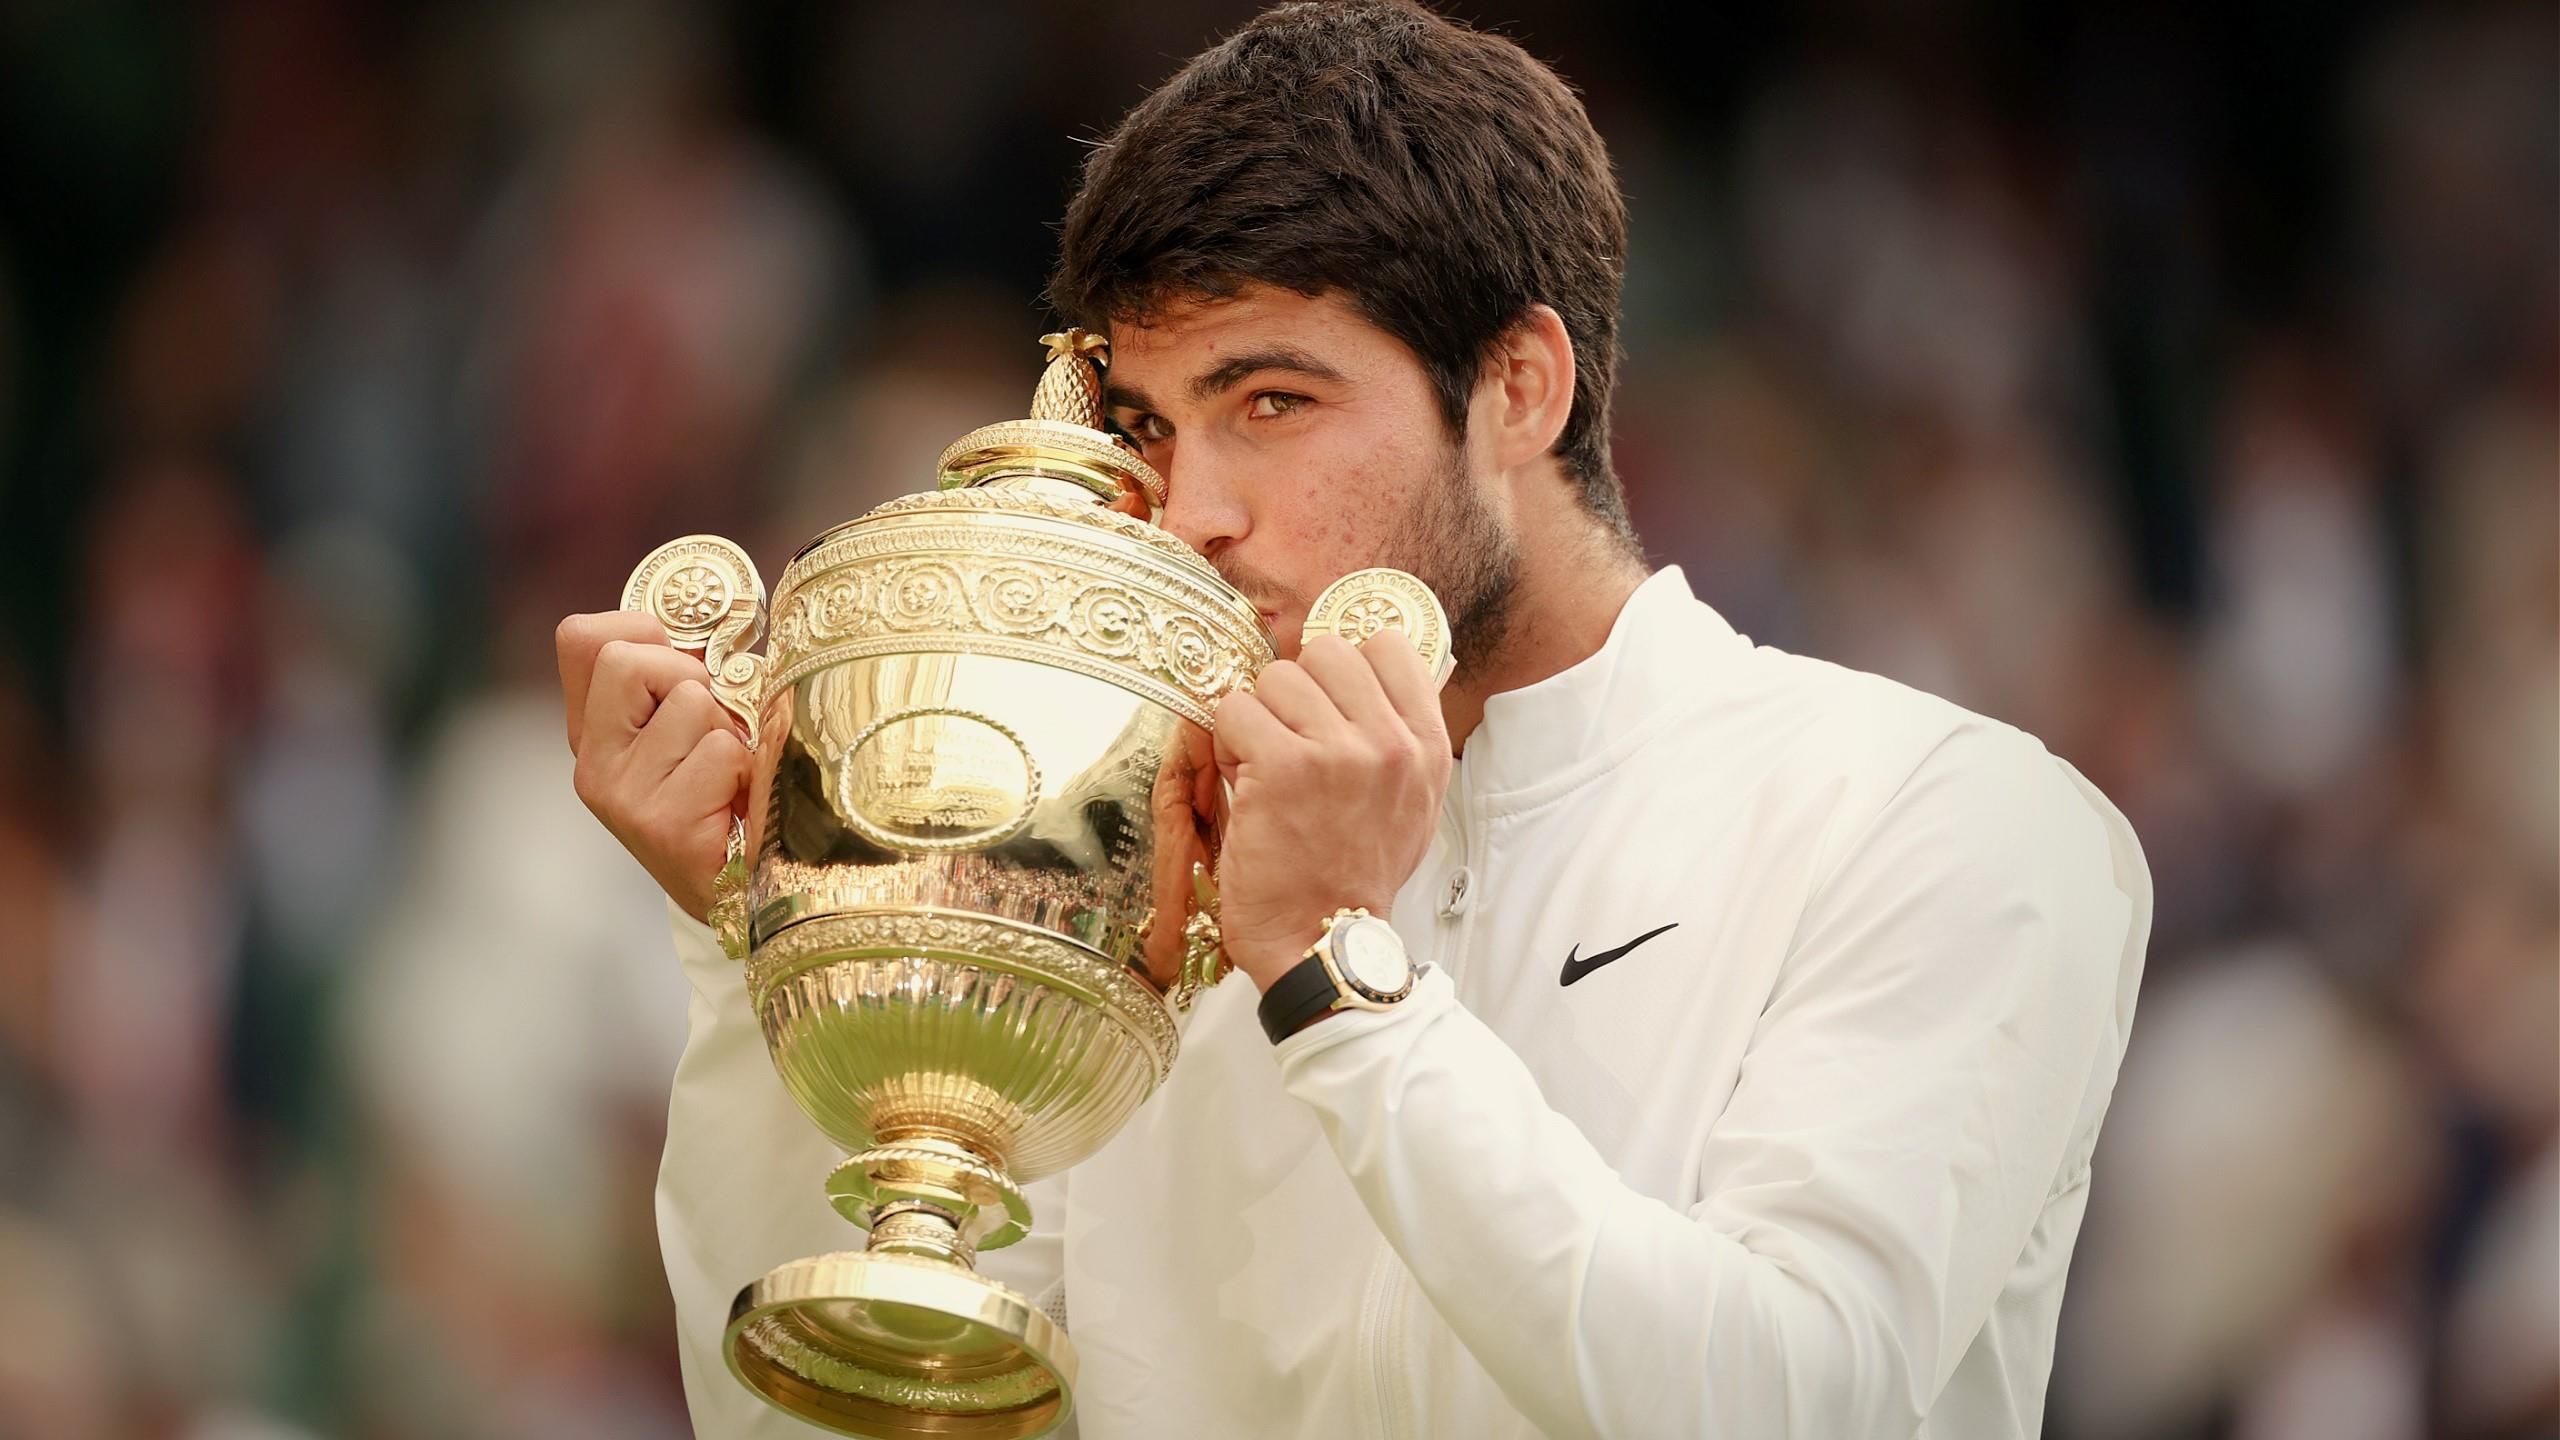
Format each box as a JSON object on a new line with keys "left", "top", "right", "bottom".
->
{"left": 1050, "top": 0, "right": 1628, "bottom": 533}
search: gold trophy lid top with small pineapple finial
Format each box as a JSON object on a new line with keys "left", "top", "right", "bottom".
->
{"left": 937, "top": 331, "right": 1165, "bottom": 510}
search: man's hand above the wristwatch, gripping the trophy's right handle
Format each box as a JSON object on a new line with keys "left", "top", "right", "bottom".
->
{"left": 1216, "top": 630, "right": 1449, "bottom": 989}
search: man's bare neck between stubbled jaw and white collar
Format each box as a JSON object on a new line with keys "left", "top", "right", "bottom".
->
{"left": 1441, "top": 505, "right": 1646, "bottom": 753}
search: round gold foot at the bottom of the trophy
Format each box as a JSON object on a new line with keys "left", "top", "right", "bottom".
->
{"left": 722, "top": 1250, "right": 1075, "bottom": 1440}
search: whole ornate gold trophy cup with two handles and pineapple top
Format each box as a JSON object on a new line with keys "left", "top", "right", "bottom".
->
{"left": 622, "top": 331, "right": 1449, "bottom": 1440}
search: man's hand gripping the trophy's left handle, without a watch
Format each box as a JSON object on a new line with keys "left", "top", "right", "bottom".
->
{"left": 558, "top": 610, "right": 748, "bottom": 920}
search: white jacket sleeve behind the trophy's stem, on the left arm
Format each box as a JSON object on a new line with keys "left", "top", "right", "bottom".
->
{"left": 658, "top": 904, "right": 1075, "bottom": 1440}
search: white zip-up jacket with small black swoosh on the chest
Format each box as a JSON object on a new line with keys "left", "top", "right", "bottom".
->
{"left": 658, "top": 569, "right": 2150, "bottom": 1440}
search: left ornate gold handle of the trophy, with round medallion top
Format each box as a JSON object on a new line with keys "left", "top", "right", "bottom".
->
{"left": 622, "top": 536, "right": 768, "bottom": 963}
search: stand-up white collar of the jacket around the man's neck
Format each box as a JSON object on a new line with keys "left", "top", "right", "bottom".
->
{"left": 1452, "top": 566, "right": 1751, "bottom": 810}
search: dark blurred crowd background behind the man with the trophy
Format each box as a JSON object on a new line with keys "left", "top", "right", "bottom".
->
{"left": 0, "top": 0, "right": 2560, "bottom": 1440}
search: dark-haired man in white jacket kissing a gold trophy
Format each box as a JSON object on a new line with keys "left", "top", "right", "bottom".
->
{"left": 561, "top": 0, "right": 2150, "bottom": 1440}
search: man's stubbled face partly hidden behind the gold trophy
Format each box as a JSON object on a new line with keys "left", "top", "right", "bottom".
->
{"left": 1108, "top": 287, "right": 1518, "bottom": 674}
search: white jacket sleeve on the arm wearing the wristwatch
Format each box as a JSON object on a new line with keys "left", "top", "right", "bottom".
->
{"left": 1280, "top": 730, "right": 2150, "bottom": 1440}
